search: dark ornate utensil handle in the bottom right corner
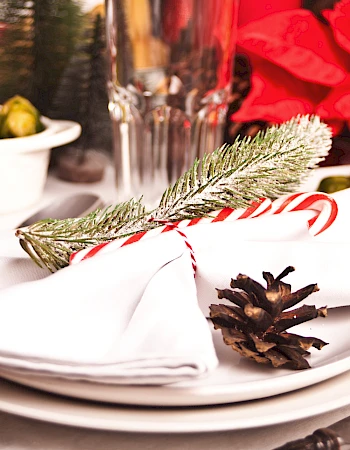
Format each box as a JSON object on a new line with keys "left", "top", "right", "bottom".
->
{"left": 274, "top": 416, "right": 350, "bottom": 450}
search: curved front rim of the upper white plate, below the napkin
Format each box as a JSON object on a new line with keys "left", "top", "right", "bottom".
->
{"left": 0, "top": 338, "right": 350, "bottom": 407}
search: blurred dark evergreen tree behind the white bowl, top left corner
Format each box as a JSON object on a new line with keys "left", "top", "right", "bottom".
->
{"left": 0, "top": 0, "right": 83, "bottom": 115}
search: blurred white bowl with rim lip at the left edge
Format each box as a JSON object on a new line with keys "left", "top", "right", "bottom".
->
{"left": 0, "top": 117, "right": 81, "bottom": 214}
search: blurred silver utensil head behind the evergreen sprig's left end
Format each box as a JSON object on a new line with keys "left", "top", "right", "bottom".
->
{"left": 16, "top": 193, "right": 104, "bottom": 228}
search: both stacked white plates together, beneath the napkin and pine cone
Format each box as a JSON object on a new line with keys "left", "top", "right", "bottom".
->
{"left": 0, "top": 308, "right": 350, "bottom": 433}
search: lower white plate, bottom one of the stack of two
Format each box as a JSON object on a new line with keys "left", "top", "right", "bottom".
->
{"left": 0, "top": 372, "right": 350, "bottom": 433}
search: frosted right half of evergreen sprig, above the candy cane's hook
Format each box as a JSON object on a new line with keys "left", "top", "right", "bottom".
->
{"left": 150, "top": 116, "right": 331, "bottom": 219}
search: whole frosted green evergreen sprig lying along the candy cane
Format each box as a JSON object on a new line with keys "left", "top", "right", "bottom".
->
{"left": 16, "top": 116, "right": 331, "bottom": 271}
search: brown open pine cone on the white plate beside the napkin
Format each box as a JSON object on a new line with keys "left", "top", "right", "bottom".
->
{"left": 210, "top": 266, "right": 327, "bottom": 369}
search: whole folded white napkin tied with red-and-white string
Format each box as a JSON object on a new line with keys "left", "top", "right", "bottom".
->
{"left": 0, "top": 190, "right": 350, "bottom": 384}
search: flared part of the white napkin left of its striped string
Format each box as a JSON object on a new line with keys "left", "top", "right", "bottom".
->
{"left": 0, "top": 234, "right": 217, "bottom": 384}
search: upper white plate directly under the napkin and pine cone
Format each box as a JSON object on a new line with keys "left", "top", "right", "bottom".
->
{"left": 0, "top": 308, "right": 350, "bottom": 406}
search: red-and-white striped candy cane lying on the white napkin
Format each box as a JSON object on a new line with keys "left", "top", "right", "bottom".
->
{"left": 70, "top": 192, "right": 338, "bottom": 264}
